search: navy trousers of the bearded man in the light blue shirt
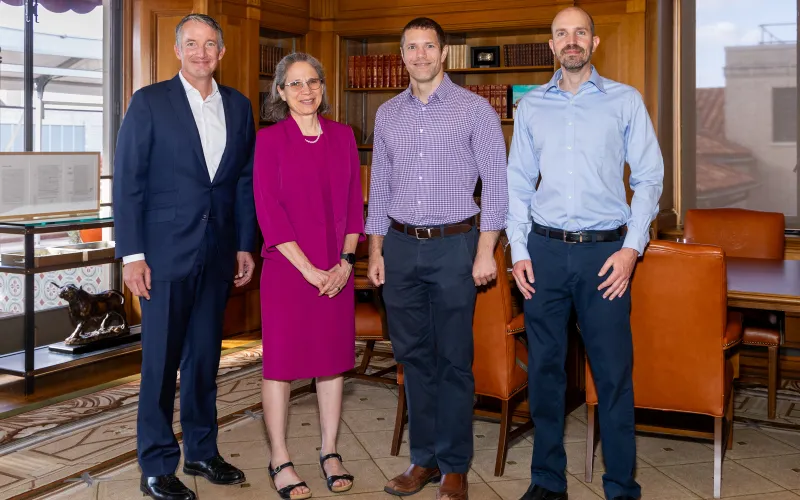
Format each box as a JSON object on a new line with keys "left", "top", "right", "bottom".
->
{"left": 524, "top": 231, "right": 641, "bottom": 499}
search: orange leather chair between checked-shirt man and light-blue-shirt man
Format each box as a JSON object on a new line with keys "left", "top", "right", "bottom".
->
{"left": 391, "top": 243, "right": 533, "bottom": 476}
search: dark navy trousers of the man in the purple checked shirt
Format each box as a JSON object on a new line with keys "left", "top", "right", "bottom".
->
{"left": 383, "top": 228, "right": 478, "bottom": 474}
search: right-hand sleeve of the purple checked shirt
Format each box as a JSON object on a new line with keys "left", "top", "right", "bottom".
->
{"left": 472, "top": 99, "right": 508, "bottom": 231}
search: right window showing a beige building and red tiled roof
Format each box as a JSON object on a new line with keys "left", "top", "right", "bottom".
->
{"left": 678, "top": 0, "right": 800, "bottom": 227}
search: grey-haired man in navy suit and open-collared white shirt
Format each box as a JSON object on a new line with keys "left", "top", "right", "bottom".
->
{"left": 114, "top": 14, "right": 257, "bottom": 500}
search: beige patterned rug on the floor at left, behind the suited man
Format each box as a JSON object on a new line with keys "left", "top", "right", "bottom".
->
{"left": 0, "top": 342, "right": 282, "bottom": 498}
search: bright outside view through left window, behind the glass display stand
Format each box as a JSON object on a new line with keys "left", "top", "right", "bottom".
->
{"left": 0, "top": 2, "right": 111, "bottom": 316}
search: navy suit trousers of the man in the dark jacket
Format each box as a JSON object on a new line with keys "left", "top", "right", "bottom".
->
{"left": 137, "top": 229, "right": 233, "bottom": 476}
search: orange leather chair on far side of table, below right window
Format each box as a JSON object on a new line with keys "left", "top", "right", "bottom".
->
{"left": 683, "top": 208, "right": 786, "bottom": 418}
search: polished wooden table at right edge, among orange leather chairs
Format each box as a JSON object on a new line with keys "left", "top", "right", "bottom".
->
{"left": 726, "top": 258, "right": 800, "bottom": 312}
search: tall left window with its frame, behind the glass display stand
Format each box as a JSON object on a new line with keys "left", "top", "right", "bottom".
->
{"left": 0, "top": 0, "right": 122, "bottom": 316}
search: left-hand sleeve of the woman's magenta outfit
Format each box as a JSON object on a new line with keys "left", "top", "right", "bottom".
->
{"left": 253, "top": 129, "right": 297, "bottom": 248}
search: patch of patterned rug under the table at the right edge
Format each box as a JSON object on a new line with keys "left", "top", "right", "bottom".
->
{"left": 733, "top": 380, "right": 800, "bottom": 430}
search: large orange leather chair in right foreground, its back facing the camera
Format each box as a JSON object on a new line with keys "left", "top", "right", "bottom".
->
{"left": 586, "top": 241, "right": 742, "bottom": 498}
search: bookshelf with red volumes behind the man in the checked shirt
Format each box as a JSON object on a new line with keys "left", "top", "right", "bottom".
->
{"left": 336, "top": 26, "right": 556, "bottom": 165}
